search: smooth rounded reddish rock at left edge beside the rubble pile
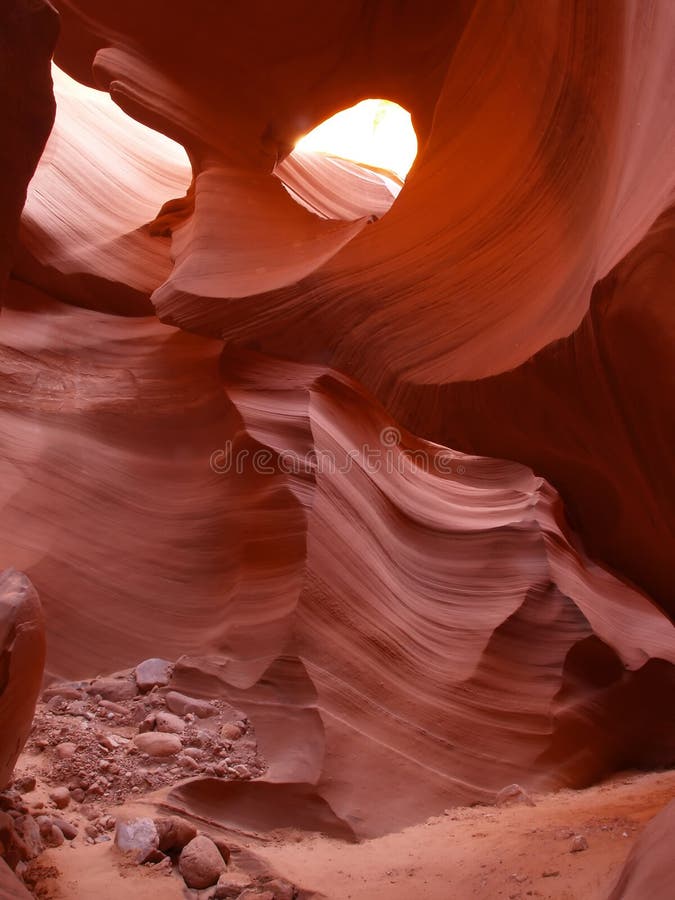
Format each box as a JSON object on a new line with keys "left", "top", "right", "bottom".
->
{"left": 0, "top": 569, "right": 45, "bottom": 789}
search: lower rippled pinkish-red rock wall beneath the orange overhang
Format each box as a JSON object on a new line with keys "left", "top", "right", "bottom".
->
{"left": 1, "top": 285, "right": 675, "bottom": 835}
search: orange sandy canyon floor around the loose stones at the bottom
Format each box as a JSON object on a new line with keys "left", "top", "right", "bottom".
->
{"left": 18, "top": 724, "right": 675, "bottom": 900}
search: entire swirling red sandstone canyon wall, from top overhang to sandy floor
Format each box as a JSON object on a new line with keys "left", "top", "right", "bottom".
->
{"left": 0, "top": 0, "right": 675, "bottom": 837}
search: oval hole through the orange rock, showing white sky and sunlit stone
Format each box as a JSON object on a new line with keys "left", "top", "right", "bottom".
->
{"left": 275, "top": 100, "right": 417, "bottom": 220}
